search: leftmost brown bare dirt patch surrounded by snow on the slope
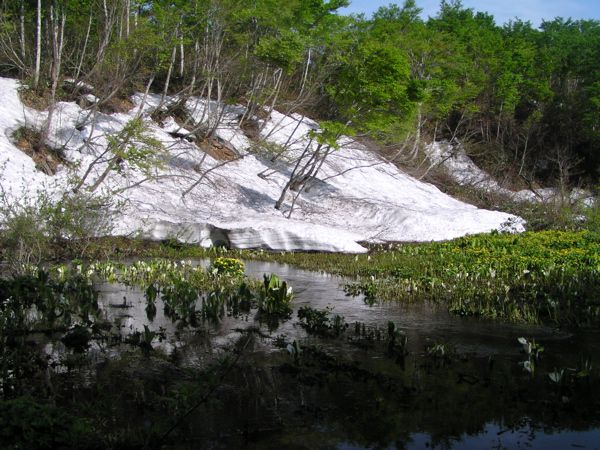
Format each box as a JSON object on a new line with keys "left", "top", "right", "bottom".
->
{"left": 12, "top": 127, "right": 67, "bottom": 176}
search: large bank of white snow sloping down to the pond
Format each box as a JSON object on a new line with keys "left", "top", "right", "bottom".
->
{"left": 0, "top": 78, "right": 523, "bottom": 253}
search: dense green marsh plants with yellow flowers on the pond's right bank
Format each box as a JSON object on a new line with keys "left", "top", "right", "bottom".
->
{"left": 342, "top": 232, "right": 600, "bottom": 325}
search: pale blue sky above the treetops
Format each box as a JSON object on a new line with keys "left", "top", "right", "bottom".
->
{"left": 340, "top": 0, "right": 600, "bottom": 27}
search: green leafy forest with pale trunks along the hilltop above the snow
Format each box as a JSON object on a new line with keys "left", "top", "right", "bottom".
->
{"left": 0, "top": 0, "right": 600, "bottom": 184}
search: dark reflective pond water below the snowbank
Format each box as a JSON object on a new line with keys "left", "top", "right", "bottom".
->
{"left": 91, "top": 261, "right": 600, "bottom": 449}
